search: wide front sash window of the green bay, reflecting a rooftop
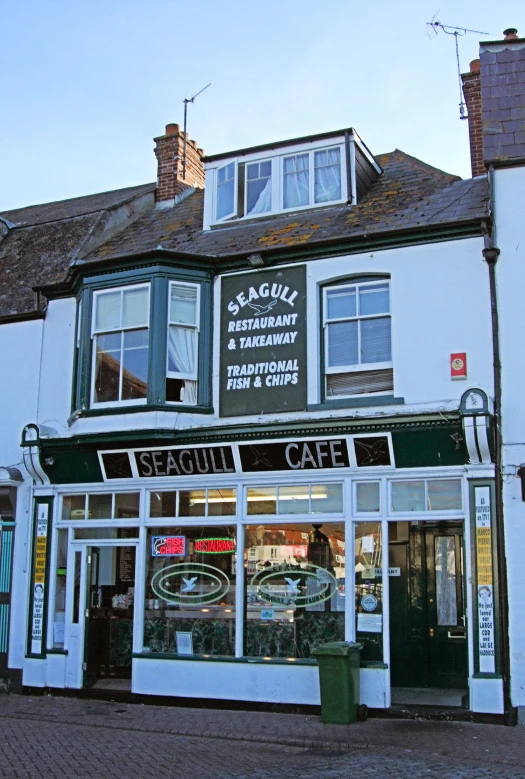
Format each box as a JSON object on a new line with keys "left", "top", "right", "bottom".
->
{"left": 92, "top": 284, "right": 149, "bottom": 404}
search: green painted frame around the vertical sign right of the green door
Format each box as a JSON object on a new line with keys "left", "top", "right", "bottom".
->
{"left": 468, "top": 479, "right": 502, "bottom": 679}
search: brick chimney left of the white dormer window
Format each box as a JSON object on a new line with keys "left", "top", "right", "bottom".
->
{"left": 153, "top": 124, "right": 204, "bottom": 203}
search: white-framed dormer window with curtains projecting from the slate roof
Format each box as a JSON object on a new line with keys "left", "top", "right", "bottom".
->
{"left": 204, "top": 130, "right": 381, "bottom": 229}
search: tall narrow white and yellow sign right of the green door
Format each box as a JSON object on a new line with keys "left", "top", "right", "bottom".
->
{"left": 474, "top": 487, "right": 496, "bottom": 673}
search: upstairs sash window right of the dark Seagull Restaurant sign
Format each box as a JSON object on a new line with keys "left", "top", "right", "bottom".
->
{"left": 323, "top": 281, "right": 393, "bottom": 397}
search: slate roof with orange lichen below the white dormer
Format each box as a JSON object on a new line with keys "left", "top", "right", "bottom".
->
{"left": 85, "top": 149, "right": 488, "bottom": 262}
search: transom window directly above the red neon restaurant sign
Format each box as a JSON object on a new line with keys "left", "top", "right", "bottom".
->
{"left": 149, "top": 488, "right": 237, "bottom": 519}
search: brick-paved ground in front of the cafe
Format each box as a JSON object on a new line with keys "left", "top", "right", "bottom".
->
{"left": 0, "top": 695, "right": 525, "bottom": 779}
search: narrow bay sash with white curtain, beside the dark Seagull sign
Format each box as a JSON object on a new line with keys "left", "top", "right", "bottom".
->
{"left": 166, "top": 281, "right": 200, "bottom": 405}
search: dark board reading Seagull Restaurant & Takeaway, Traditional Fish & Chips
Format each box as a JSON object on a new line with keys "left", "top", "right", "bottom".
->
{"left": 220, "top": 265, "right": 306, "bottom": 417}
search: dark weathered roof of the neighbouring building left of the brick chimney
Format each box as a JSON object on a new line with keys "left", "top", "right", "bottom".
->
{"left": 0, "top": 184, "right": 155, "bottom": 318}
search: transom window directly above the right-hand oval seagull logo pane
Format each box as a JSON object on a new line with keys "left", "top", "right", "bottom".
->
{"left": 247, "top": 484, "right": 343, "bottom": 515}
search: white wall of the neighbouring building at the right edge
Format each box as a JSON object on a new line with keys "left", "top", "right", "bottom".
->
{"left": 494, "top": 168, "right": 525, "bottom": 706}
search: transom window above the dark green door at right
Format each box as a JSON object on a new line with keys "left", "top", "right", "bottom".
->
{"left": 390, "top": 479, "right": 462, "bottom": 512}
